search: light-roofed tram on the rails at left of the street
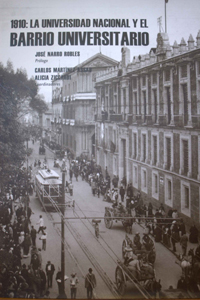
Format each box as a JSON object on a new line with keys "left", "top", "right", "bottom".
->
{"left": 35, "top": 169, "right": 62, "bottom": 210}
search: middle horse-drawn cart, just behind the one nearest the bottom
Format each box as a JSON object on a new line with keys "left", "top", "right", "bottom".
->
{"left": 122, "top": 234, "right": 156, "bottom": 264}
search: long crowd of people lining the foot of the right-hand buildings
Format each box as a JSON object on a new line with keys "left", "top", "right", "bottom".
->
{"left": 64, "top": 157, "right": 199, "bottom": 255}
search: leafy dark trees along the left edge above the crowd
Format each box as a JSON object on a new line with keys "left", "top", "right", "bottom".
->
{"left": 0, "top": 61, "right": 48, "bottom": 189}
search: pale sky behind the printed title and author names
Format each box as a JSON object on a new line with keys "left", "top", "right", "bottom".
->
{"left": 0, "top": 0, "right": 200, "bottom": 102}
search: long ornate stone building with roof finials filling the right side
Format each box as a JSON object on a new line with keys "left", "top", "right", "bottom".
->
{"left": 96, "top": 31, "right": 200, "bottom": 223}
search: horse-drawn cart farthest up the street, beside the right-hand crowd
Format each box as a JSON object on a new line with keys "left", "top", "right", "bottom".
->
{"left": 104, "top": 204, "right": 134, "bottom": 233}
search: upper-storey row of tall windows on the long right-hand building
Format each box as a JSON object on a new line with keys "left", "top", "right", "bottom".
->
{"left": 97, "top": 62, "right": 200, "bottom": 126}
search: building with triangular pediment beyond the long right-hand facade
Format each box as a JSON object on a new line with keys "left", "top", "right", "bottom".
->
{"left": 52, "top": 53, "right": 118, "bottom": 157}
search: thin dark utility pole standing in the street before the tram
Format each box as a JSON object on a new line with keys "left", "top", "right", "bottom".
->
{"left": 58, "top": 169, "right": 67, "bottom": 299}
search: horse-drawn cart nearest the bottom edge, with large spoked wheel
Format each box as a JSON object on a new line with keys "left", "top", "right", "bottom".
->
{"left": 115, "top": 260, "right": 155, "bottom": 296}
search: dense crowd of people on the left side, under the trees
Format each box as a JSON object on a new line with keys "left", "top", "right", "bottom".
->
{"left": 0, "top": 168, "right": 52, "bottom": 298}
